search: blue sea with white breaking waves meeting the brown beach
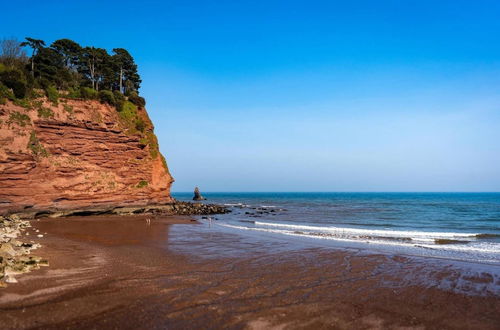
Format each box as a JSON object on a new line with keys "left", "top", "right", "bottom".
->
{"left": 173, "top": 193, "right": 500, "bottom": 264}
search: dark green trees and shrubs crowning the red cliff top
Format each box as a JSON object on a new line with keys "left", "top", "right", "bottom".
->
{"left": 0, "top": 38, "right": 146, "bottom": 108}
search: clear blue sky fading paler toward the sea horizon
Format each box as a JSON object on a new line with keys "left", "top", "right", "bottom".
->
{"left": 0, "top": 0, "right": 500, "bottom": 192}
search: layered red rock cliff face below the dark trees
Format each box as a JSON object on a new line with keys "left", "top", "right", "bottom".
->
{"left": 0, "top": 98, "right": 173, "bottom": 214}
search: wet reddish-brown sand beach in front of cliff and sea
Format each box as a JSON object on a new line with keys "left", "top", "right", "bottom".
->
{"left": 0, "top": 216, "right": 500, "bottom": 329}
